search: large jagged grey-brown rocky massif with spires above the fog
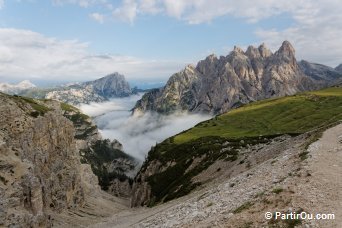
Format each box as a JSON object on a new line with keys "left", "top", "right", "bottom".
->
{"left": 133, "top": 41, "right": 335, "bottom": 114}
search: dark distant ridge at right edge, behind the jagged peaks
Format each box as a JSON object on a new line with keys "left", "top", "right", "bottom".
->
{"left": 298, "top": 60, "right": 342, "bottom": 82}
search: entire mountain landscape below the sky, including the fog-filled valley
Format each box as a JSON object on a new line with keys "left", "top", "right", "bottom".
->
{"left": 0, "top": 41, "right": 342, "bottom": 227}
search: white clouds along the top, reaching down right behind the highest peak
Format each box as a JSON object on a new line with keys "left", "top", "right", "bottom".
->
{"left": 56, "top": 0, "right": 342, "bottom": 67}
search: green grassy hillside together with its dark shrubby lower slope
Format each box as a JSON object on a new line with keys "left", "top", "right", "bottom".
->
{"left": 136, "top": 87, "right": 342, "bottom": 206}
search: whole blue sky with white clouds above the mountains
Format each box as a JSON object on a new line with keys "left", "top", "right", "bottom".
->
{"left": 0, "top": 0, "right": 342, "bottom": 84}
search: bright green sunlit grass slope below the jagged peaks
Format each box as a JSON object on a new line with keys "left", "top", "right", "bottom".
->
{"left": 174, "top": 87, "right": 342, "bottom": 144}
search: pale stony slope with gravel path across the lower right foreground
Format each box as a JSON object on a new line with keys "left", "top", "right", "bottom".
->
{"left": 60, "top": 124, "right": 342, "bottom": 227}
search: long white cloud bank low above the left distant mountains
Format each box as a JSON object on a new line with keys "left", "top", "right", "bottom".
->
{"left": 0, "top": 29, "right": 185, "bottom": 81}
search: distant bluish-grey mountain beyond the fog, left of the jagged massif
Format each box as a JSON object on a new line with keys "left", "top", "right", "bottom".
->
{"left": 45, "top": 73, "right": 134, "bottom": 105}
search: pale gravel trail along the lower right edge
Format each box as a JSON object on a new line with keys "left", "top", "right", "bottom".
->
{"left": 294, "top": 124, "right": 342, "bottom": 227}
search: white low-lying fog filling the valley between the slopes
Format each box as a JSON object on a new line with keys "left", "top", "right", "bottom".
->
{"left": 80, "top": 94, "right": 211, "bottom": 161}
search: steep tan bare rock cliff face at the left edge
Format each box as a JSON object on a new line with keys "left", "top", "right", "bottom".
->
{"left": 0, "top": 93, "right": 84, "bottom": 227}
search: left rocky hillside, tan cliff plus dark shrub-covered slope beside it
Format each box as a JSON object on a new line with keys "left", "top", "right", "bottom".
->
{"left": 0, "top": 93, "right": 136, "bottom": 227}
